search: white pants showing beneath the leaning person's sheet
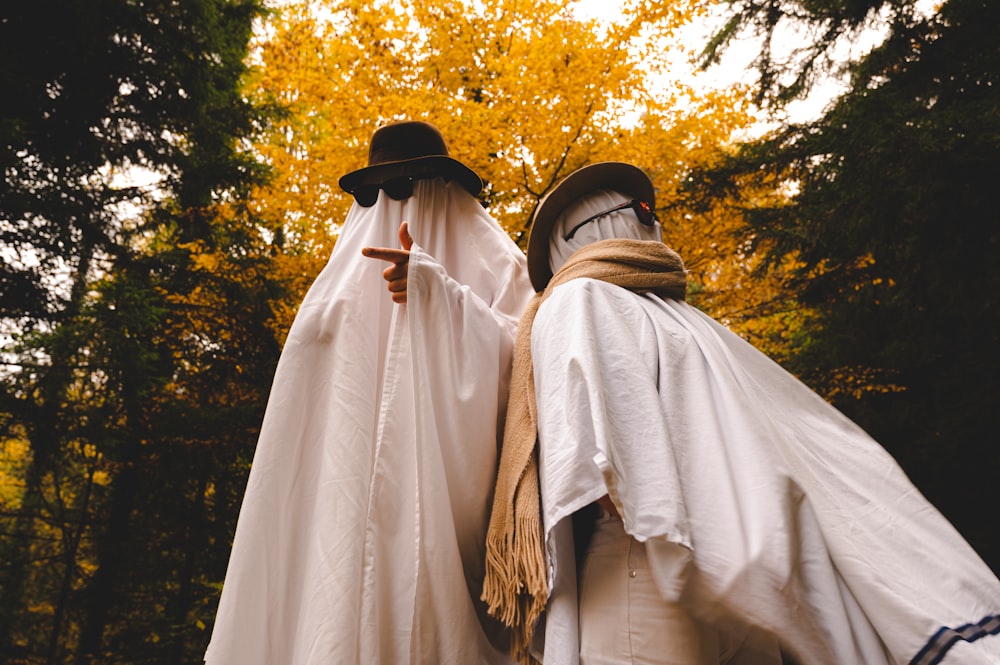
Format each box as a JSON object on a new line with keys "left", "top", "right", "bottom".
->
{"left": 579, "top": 514, "right": 720, "bottom": 665}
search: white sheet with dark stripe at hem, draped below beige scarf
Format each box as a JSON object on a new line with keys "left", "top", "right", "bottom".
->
{"left": 532, "top": 279, "right": 1000, "bottom": 665}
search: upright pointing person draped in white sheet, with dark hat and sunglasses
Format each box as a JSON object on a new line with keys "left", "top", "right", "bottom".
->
{"left": 205, "top": 122, "right": 532, "bottom": 665}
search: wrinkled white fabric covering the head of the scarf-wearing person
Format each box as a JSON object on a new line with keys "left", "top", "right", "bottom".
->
{"left": 549, "top": 189, "right": 663, "bottom": 274}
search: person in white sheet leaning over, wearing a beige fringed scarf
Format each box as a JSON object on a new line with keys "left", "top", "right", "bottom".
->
{"left": 482, "top": 162, "right": 1000, "bottom": 665}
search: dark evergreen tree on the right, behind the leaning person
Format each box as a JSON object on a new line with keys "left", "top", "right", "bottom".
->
{"left": 696, "top": 0, "right": 1000, "bottom": 570}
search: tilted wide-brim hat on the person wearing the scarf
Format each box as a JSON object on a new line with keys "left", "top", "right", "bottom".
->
{"left": 528, "top": 162, "right": 656, "bottom": 291}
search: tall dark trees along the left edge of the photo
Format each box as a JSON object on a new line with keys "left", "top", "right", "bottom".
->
{"left": 0, "top": 0, "right": 275, "bottom": 663}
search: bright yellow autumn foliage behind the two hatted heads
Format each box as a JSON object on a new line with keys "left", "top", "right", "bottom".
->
{"left": 230, "top": 0, "right": 789, "bottom": 358}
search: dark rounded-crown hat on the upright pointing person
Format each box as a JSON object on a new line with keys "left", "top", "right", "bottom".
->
{"left": 339, "top": 120, "right": 483, "bottom": 196}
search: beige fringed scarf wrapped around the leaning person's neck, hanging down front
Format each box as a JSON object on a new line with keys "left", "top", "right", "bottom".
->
{"left": 482, "top": 239, "right": 687, "bottom": 663}
